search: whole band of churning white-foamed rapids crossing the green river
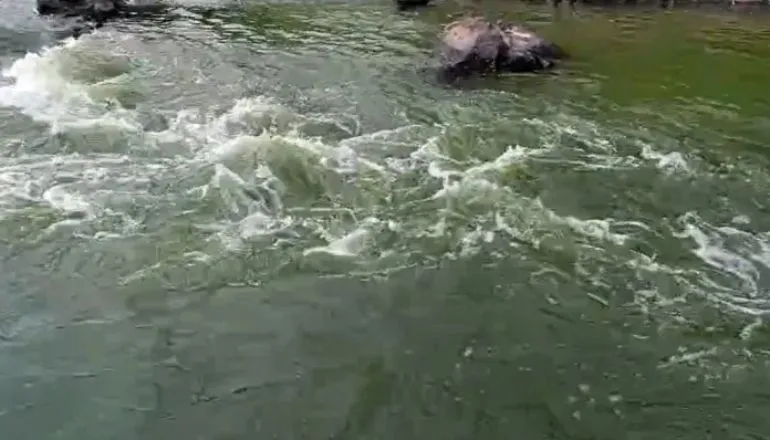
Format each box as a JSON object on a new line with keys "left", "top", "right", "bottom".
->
{"left": 0, "top": 26, "right": 770, "bottom": 372}
